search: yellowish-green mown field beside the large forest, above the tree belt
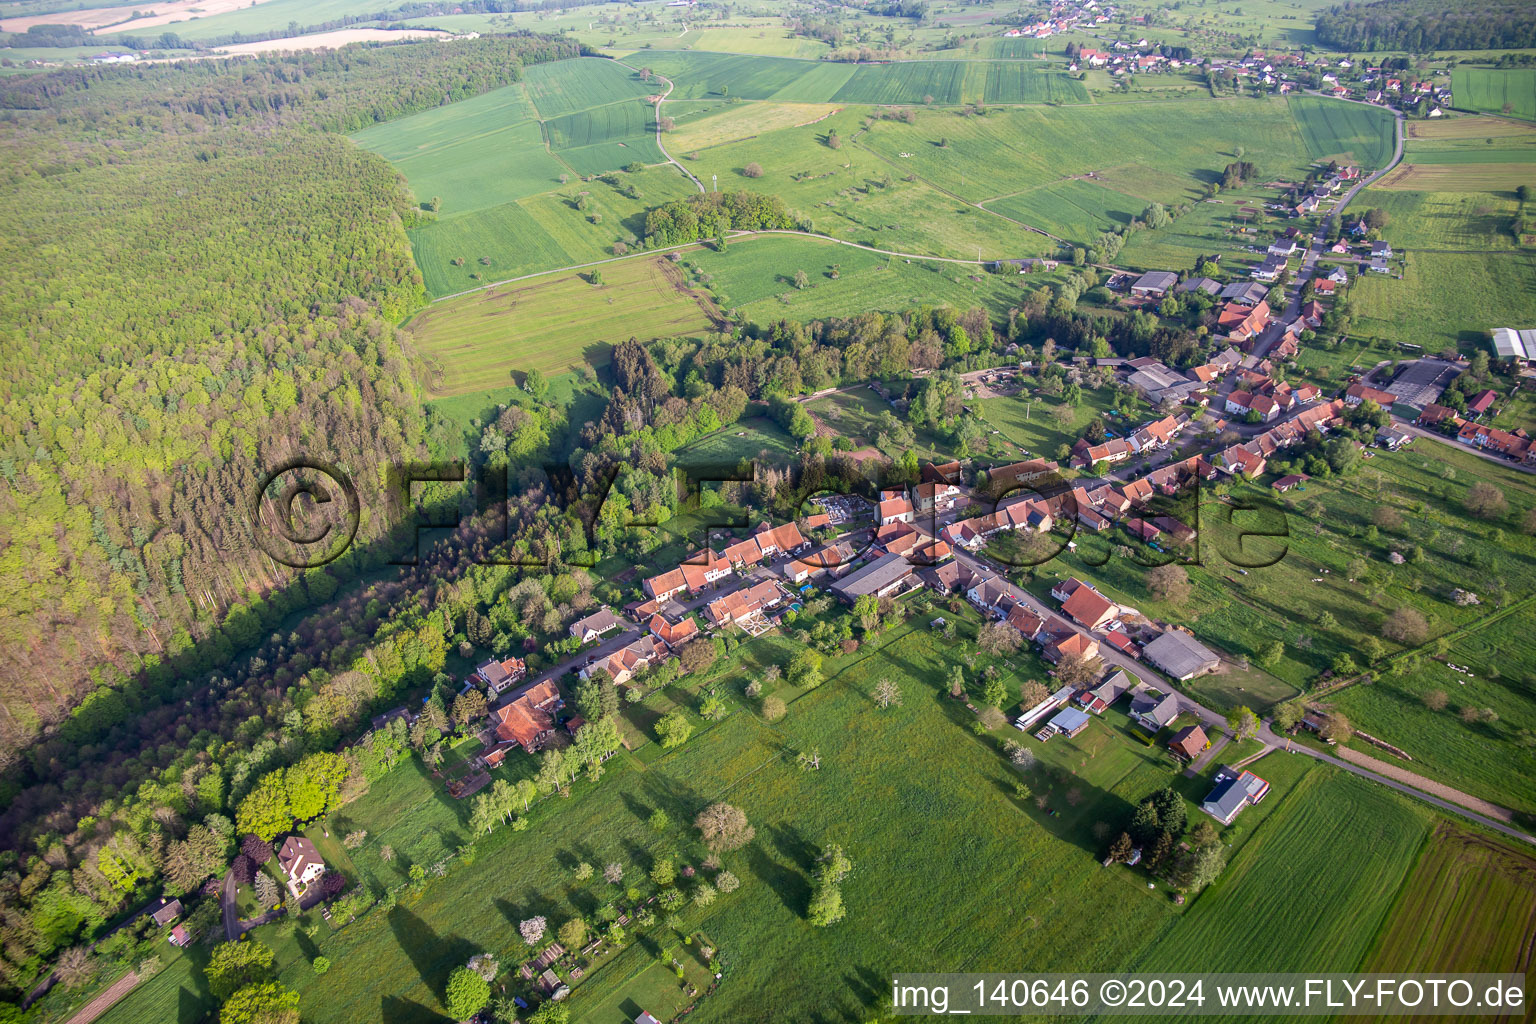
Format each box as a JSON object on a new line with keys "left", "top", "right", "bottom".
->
{"left": 410, "top": 256, "right": 716, "bottom": 396}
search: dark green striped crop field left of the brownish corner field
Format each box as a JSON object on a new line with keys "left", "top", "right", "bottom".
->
{"left": 1134, "top": 773, "right": 1432, "bottom": 982}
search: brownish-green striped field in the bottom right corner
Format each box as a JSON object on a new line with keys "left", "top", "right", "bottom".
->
{"left": 1364, "top": 821, "right": 1536, "bottom": 982}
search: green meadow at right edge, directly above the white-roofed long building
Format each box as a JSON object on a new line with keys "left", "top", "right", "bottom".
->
{"left": 1352, "top": 252, "right": 1536, "bottom": 352}
